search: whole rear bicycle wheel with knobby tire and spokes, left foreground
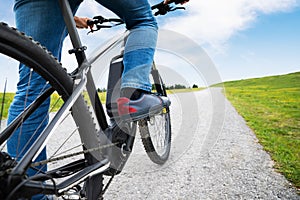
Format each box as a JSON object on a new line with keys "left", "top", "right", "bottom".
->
{"left": 0, "top": 23, "right": 103, "bottom": 200}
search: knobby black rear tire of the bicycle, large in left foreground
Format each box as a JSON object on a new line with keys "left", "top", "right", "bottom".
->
{"left": 0, "top": 22, "right": 103, "bottom": 200}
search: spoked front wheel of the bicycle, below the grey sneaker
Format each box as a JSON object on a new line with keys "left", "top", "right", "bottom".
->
{"left": 139, "top": 70, "right": 171, "bottom": 165}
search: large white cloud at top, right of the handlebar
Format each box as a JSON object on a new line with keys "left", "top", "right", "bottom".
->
{"left": 162, "top": 0, "right": 299, "bottom": 50}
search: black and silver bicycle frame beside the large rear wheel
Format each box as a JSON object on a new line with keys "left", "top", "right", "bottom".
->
{"left": 3, "top": 0, "right": 126, "bottom": 194}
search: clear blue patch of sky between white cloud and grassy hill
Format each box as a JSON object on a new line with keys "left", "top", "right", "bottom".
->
{"left": 214, "top": 7, "right": 300, "bottom": 81}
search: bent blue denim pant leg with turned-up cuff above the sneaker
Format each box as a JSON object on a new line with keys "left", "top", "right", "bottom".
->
{"left": 96, "top": 0, "right": 157, "bottom": 91}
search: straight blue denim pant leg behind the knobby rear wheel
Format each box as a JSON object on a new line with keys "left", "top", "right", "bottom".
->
{"left": 7, "top": 0, "right": 81, "bottom": 179}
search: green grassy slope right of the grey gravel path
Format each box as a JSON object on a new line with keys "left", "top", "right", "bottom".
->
{"left": 220, "top": 72, "right": 300, "bottom": 188}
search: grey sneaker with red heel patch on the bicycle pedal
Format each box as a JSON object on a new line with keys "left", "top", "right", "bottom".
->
{"left": 117, "top": 94, "right": 171, "bottom": 121}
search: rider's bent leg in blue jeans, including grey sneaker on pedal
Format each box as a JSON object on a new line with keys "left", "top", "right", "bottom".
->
{"left": 97, "top": 0, "right": 170, "bottom": 120}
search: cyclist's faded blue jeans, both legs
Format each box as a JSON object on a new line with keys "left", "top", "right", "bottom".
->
{"left": 7, "top": 0, "right": 157, "bottom": 198}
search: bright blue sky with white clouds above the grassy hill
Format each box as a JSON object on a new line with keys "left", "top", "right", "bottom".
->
{"left": 0, "top": 0, "right": 300, "bottom": 90}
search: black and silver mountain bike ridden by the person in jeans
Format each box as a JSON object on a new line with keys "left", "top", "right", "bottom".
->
{"left": 0, "top": 0, "right": 186, "bottom": 200}
